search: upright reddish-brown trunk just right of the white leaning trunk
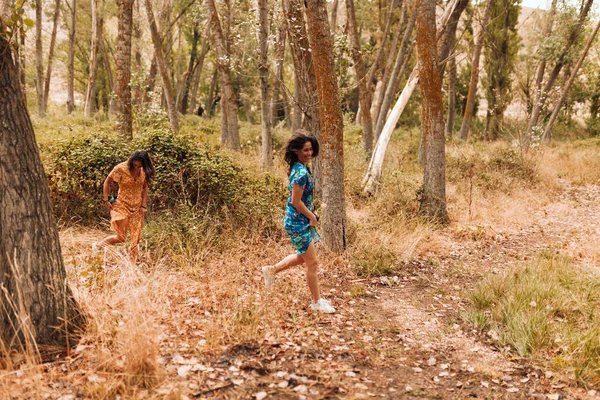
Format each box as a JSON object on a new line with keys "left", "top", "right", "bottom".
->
{"left": 416, "top": 0, "right": 448, "bottom": 223}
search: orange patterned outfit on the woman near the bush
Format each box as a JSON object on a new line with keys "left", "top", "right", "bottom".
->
{"left": 108, "top": 162, "right": 146, "bottom": 259}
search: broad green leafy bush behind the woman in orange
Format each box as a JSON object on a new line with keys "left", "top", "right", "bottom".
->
{"left": 42, "top": 128, "right": 285, "bottom": 228}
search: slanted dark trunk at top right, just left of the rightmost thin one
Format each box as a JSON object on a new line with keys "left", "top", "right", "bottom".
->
{"left": 523, "top": 0, "right": 594, "bottom": 152}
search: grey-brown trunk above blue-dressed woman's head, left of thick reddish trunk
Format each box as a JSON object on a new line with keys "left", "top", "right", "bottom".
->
{"left": 283, "top": 0, "right": 327, "bottom": 188}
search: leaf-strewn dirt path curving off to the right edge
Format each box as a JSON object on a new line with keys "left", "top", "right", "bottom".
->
{"left": 144, "top": 186, "right": 600, "bottom": 399}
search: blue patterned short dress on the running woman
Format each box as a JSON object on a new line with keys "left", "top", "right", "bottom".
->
{"left": 283, "top": 163, "right": 320, "bottom": 254}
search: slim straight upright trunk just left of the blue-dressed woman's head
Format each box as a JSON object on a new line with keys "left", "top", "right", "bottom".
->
{"left": 257, "top": 0, "right": 273, "bottom": 168}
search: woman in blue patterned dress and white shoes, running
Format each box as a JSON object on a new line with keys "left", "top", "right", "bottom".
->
{"left": 262, "top": 130, "right": 335, "bottom": 313}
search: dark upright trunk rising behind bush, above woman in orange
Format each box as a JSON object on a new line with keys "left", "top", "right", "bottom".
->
{"left": 115, "top": 0, "right": 134, "bottom": 140}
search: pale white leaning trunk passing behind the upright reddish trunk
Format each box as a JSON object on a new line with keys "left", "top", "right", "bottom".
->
{"left": 362, "top": 0, "right": 458, "bottom": 195}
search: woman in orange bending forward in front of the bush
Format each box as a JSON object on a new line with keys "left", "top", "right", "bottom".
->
{"left": 92, "top": 150, "right": 154, "bottom": 264}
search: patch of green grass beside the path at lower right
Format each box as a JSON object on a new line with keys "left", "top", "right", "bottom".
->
{"left": 463, "top": 253, "right": 600, "bottom": 384}
